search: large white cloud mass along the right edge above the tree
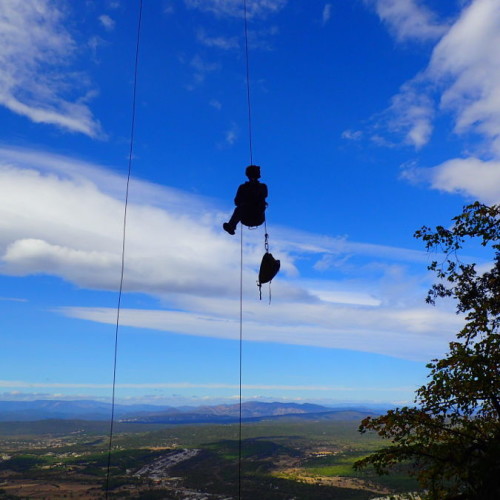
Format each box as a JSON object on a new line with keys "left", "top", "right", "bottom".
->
{"left": 414, "top": 0, "right": 500, "bottom": 203}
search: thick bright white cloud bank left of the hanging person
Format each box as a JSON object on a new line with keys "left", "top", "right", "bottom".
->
{"left": 0, "top": 146, "right": 237, "bottom": 294}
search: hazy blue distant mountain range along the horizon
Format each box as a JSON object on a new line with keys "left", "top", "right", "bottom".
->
{"left": 0, "top": 400, "right": 386, "bottom": 425}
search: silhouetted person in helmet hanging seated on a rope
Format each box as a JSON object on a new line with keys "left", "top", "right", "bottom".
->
{"left": 222, "top": 165, "right": 267, "bottom": 234}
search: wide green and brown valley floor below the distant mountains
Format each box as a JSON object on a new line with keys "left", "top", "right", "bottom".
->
{"left": 0, "top": 421, "right": 417, "bottom": 500}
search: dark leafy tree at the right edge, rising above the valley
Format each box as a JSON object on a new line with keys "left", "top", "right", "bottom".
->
{"left": 355, "top": 202, "right": 500, "bottom": 500}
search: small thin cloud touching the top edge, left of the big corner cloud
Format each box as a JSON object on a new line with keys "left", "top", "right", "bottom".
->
{"left": 367, "top": 0, "right": 447, "bottom": 41}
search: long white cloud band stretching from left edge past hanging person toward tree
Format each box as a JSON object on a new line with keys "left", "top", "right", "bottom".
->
{"left": 0, "top": 148, "right": 460, "bottom": 360}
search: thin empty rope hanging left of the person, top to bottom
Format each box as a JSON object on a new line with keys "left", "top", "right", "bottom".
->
{"left": 106, "top": 0, "right": 142, "bottom": 492}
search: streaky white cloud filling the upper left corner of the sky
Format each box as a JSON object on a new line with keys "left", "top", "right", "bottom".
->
{"left": 0, "top": 0, "right": 102, "bottom": 137}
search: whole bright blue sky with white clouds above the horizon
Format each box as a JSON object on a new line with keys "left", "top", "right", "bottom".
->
{"left": 0, "top": 0, "right": 500, "bottom": 404}
